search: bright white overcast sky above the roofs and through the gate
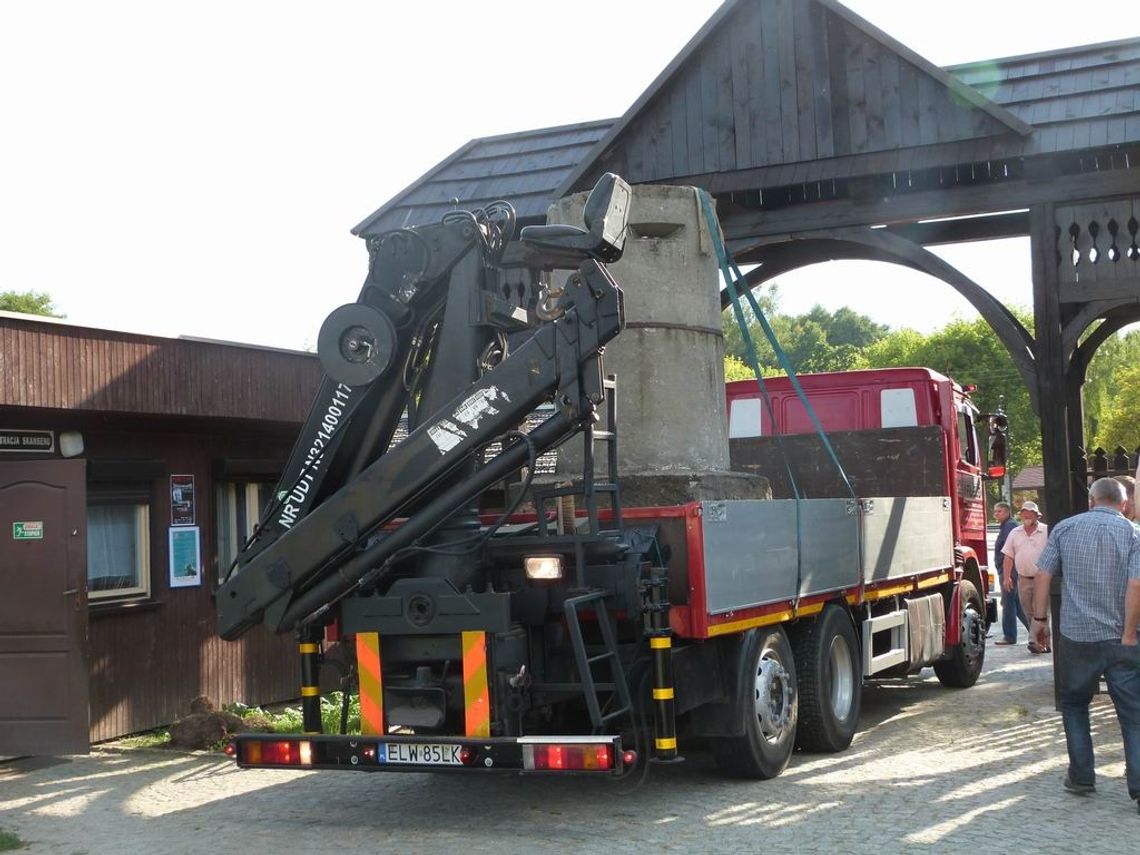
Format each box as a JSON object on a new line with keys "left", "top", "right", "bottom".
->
{"left": 0, "top": 0, "right": 1126, "bottom": 349}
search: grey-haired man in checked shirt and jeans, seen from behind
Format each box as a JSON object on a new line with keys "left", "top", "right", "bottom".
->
{"left": 1029, "top": 478, "right": 1140, "bottom": 809}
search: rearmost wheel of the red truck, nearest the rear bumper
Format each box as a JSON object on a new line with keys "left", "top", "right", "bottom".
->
{"left": 710, "top": 627, "right": 798, "bottom": 779}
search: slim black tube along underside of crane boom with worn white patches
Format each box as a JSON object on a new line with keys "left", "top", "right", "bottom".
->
{"left": 275, "top": 410, "right": 577, "bottom": 633}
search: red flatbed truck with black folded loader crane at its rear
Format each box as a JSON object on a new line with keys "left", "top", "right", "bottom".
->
{"left": 217, "top": 176, "right": 1007, "bottom": 777}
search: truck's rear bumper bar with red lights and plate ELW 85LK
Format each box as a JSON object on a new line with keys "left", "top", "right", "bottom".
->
{"left": 226, "top": 733, "right": 637, "bottom": 776}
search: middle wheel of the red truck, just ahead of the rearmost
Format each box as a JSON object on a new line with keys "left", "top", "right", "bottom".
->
{"left": 792, "top": 605, "right": 863, "bottom": 751}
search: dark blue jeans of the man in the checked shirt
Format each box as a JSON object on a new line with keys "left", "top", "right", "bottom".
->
{"left": 1058, "top": 635, "right": 1140, "bottom": 799}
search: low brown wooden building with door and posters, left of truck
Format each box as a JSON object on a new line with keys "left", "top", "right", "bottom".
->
{"left": 0, "top": 314, "right": 320, "bottom": 755}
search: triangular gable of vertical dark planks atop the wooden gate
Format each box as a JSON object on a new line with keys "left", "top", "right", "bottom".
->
{"left": 586, "top": 0, "right": 1011, "bottom": 189}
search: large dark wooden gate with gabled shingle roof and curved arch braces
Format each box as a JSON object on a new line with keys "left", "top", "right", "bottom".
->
{"left": 355, "top": 0, "right": 1140, "bottom": 528}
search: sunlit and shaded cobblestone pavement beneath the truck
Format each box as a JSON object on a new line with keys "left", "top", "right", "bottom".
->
{"left": 0, "top": 633, "right": 1140, "bottom": 855}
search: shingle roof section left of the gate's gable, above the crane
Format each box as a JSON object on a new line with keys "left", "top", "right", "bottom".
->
{"left": 352, "top": 119, "right": 616, "bottom": 237}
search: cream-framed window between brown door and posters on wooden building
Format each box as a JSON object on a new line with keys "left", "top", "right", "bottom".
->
{"left": 87, "top": 506, "right": 150, "bottom": 600}
